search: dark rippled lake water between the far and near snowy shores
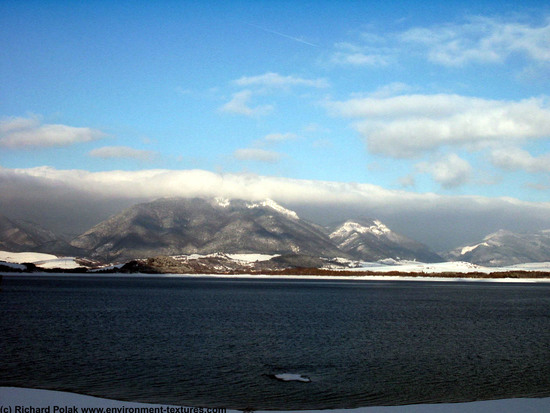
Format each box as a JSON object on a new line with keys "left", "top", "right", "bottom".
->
{"left": 0, "top": 277, "right": 550, "bottom": 410}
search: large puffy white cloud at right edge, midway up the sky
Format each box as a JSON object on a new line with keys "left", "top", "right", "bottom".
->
{"left": 326, "top": 94, "right": 550, "bottom": 157}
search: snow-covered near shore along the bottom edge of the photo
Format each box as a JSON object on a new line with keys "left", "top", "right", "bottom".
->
{"left": 0, "top": 386, "right": 550, "bottom": 413}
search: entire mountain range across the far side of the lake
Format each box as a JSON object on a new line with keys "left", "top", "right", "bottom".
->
{"left": 0, "top": 198, "right": 550, "bottom": 266}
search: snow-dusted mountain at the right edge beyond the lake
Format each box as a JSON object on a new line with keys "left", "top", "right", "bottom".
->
{"left": 445, "top": 230, "right": 550, "bottom": 266}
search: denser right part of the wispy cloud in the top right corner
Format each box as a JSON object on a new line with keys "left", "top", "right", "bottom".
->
{"left": 398, "top": 17, "right": 550, "bottom": 66}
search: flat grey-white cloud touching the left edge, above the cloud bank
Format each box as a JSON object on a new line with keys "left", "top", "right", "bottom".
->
{"left": 0, "top": 118, "right": 104, "bottom": 149}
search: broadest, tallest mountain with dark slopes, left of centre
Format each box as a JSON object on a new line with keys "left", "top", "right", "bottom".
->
{"left": 71, "top": 198, "right": 348, "bottom": 261}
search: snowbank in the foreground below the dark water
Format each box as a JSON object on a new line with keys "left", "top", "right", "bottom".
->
{"left": 0, "top": 387, "right": 550, "bottom": 413}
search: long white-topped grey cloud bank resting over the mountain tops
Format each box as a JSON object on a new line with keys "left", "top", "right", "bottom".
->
{"left": 0, "top": 163, "right": 550, "bottom": 250}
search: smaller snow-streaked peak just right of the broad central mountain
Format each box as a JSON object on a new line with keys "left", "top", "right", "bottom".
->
{"left": 329, "top": 220, "right": 442, "bottom": 262}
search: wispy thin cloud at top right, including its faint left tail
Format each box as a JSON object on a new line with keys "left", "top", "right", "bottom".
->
{"left": 329, "top": 17, "right": 550, "bottom": 67}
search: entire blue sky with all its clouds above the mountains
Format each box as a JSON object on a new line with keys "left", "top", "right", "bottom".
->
{"left": 0, "top": 0, "right": 550, "bottom": 250}
